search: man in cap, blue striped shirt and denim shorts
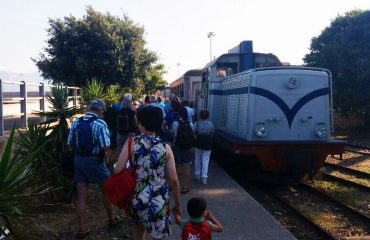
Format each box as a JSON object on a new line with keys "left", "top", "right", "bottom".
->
{"left": 68, "top": 99, "right": 117, "bottom": 238}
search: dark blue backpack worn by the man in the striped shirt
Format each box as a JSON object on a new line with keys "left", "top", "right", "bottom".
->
{"left": 71, "top": 115, "right": 98, "bottom": 156}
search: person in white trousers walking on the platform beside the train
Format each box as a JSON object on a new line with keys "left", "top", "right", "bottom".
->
{"left": 194, "top": 109, "right": 214, "bottom": 184}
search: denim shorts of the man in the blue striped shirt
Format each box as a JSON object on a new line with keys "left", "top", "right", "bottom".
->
{"left": 74, "top": 155, "right": 110, "bottom": 184}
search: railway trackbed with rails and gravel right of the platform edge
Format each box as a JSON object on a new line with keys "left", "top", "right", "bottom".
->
{"left": 215, "top": 147, "right": 370, "bottom": 240}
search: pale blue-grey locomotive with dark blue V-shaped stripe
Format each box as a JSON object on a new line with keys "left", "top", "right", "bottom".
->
{"left": 169, "top": 41, "right": 346, "bottom": 181}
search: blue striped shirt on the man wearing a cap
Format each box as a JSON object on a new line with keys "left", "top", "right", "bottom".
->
{"left": 67, "top": 113, "right": 110, "bottom": 154}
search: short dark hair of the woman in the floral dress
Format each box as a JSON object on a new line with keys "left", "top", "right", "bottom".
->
{"left": 137, "top": 106, "right": 163, "bottom": 132}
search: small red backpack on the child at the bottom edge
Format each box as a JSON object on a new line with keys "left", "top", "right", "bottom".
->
{"left": 181, "top": 220, "right": 212, "bottom": 240}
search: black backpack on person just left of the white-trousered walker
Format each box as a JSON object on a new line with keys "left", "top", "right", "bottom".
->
{"left": 175, "top": 121, "right": 195, "bottom": 150}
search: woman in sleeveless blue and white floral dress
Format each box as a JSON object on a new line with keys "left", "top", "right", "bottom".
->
{"left": 114, "top": 106, "right": 181, "bottom": 240}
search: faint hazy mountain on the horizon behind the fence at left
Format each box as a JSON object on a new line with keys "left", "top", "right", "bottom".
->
{"left": 0, "top": 71, "right": 48, "bottom": 92}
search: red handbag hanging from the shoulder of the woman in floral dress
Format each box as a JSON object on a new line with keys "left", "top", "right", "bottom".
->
{"left": 103, "top": 137, "right": 136, "bottom": 209}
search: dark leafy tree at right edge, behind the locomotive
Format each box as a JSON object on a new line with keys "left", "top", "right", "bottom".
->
{"left": 304, "top": 10, "right": 370, "bottom": 126}
